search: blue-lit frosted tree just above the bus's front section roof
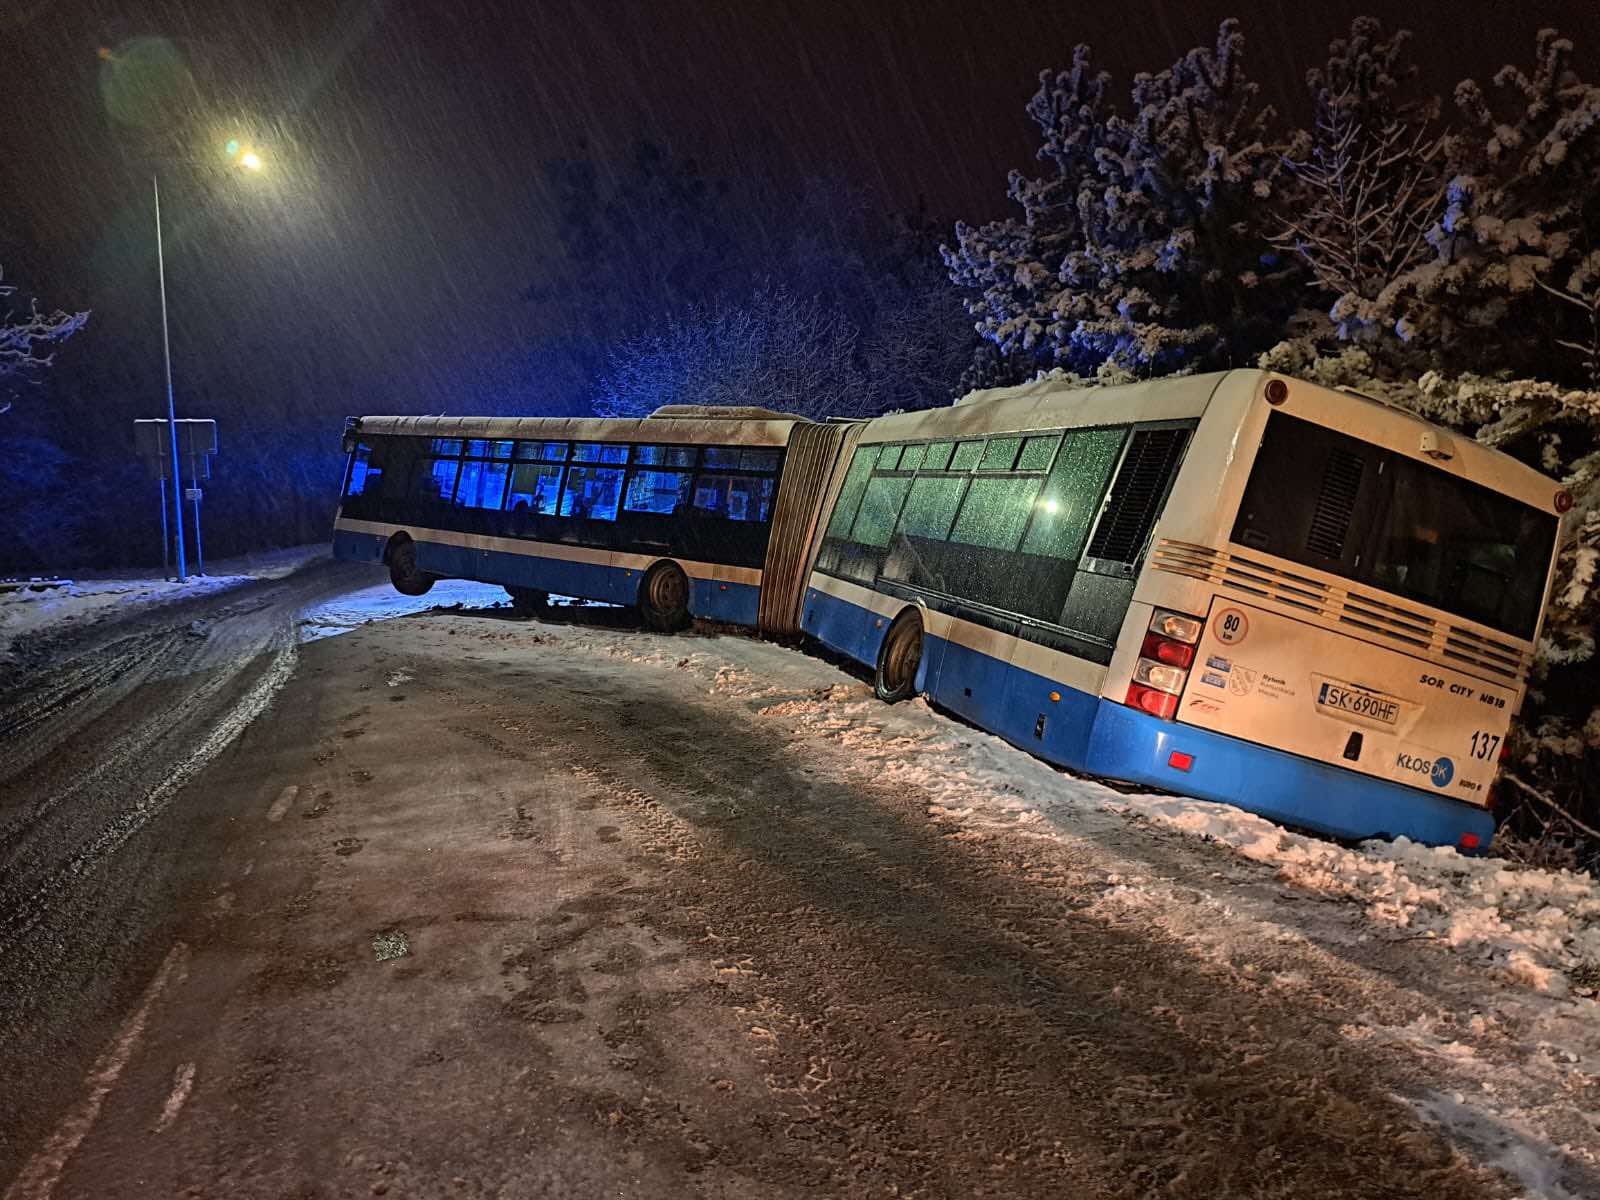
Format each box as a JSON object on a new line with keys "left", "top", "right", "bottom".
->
{"left": 594, "top": 285, "right": 872, "bottom": 418}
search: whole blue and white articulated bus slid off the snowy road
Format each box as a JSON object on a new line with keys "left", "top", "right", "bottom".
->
{"left": 334, "top": 371, "right": 1571, "bottom": 851}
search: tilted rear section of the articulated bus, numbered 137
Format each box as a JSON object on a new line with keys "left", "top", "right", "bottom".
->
{"left": 802, "top": 371, "right": 1571, "bottom": 850}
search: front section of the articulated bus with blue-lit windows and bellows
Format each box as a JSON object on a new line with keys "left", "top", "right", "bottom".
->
{"left": 333, "top": 406, "right": 843, "bottom": 632}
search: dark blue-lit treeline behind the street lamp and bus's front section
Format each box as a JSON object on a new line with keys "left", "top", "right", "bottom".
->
{"left": 0, "top": 142, "right": 974, "bottom": 571}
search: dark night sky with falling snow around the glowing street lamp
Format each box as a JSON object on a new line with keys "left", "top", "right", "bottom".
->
{"left": 0, "top": 0, "right": 1600, "bottom": 413}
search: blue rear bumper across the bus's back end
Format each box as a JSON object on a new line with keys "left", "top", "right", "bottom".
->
{"left": 1085, "top": 699, "right": 1494, "bottom": 854}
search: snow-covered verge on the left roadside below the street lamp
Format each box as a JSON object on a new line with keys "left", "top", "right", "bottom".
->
{"left": 0, "top": 542, "right": 328, "bottom": 661}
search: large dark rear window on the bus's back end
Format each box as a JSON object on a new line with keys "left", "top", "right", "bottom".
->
{"left": 1234, "top": 413, "right": 1557, "bottom": 638}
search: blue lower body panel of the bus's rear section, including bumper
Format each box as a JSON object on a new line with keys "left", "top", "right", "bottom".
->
{"left": 802, "top": 589, "right": 1494, "bottom": 851}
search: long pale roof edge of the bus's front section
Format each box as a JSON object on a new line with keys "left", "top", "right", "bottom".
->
{"left": 349, "top": 416, "right": 805, "bottom": 446}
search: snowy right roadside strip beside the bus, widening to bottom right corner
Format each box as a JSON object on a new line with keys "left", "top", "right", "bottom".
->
{"left": 301, "top": 582, "right": 1600, "bottom": 1200}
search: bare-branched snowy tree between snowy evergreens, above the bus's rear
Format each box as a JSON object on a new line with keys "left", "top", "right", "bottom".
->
{"left": 1274, "top": 16, "right": 1445, "bottom": 349}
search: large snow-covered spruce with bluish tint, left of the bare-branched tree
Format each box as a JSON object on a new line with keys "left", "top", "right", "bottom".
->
{"left": 944, "top": 21, "right": 1296, "bottom": 382}
